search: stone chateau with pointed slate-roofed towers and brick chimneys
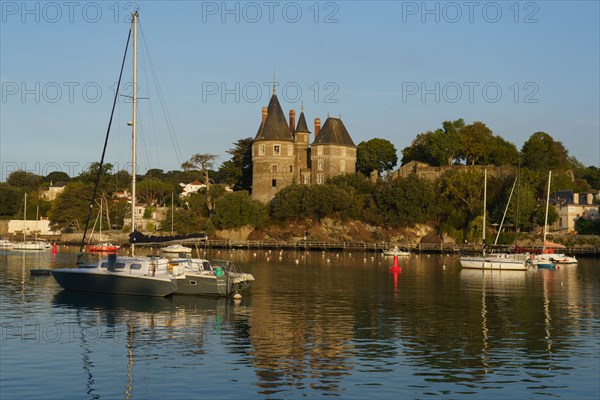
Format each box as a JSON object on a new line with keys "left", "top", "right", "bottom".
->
{"left": 252, "top": 88, "right": 356, "bottom": 203}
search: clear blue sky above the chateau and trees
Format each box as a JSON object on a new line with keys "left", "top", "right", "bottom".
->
{"left": 0, "top": 0, "right": 600, "bottom": 181}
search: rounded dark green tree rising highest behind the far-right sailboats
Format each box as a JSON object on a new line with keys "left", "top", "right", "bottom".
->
{"left": 521, "top": 132, "right": 569, "bottom": 171}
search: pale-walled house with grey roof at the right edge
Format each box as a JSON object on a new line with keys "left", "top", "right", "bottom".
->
{"left": 552, "top": 190, "right": 600, "bottom": 233}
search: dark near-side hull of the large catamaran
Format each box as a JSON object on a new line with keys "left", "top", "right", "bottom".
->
{"left": 52, "top": 268, "right": 177, "bottom": 297}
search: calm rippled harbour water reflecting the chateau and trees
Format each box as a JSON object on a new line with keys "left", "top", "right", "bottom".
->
{"left": 0, "top": 250, "right": 600, "bottom": 400}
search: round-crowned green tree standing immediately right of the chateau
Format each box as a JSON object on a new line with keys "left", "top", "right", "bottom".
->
{"left": 356, "top": 138, "right": 398, "bottom": 176}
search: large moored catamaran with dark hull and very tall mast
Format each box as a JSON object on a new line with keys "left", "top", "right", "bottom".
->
{"left": 52, "top": 11, "right": 254, "bottom": 296}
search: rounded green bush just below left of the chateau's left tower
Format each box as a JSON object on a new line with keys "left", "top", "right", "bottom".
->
{"left": 211, "top": 190, "right": 268, "bottom": 229}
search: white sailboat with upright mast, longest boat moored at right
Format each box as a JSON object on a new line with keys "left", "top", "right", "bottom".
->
{"left": 460, "top": 170, "right": 531, "bottom": 271}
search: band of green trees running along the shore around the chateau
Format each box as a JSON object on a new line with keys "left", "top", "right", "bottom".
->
{"left": 0, "top": 119, "right": 600, "bottom": 240}
